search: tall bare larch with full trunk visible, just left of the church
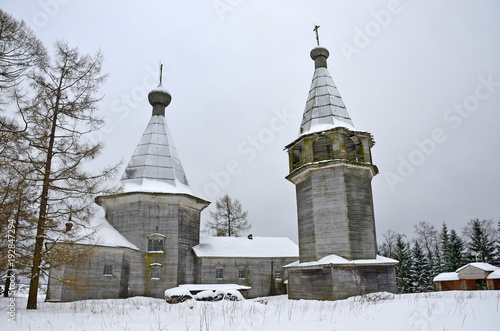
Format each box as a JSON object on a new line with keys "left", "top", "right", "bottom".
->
{"left": 24, "top": 42, "right": 116, "bottom": 309}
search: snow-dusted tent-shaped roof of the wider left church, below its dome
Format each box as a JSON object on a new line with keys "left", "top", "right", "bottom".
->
{"left": 121, "top": 115, "right": 193, "bottom": 194}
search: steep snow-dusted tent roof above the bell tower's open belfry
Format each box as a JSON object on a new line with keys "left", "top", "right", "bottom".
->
{"left": 299, "top": 67, "right": 356, "bottom": 136}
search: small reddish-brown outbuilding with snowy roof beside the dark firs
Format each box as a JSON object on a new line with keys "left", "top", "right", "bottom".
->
{"left": 434, "top": 262, "right": 500, "bottom": 291}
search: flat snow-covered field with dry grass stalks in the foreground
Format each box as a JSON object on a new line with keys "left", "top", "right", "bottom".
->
{"left": 0, "top": 291, "right": 500, "bottom": 331}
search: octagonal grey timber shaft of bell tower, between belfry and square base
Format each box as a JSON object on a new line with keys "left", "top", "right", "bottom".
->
{"left": 287, "top": 152, "right": 377, "bottom": 262}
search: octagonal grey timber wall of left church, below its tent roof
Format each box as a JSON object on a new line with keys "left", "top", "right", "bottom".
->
{"left": 96, "top": 192, "right": 208, "bottom": 297}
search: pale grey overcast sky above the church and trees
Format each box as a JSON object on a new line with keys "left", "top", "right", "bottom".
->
{"left": 1, "top": 0, "right": 500, "bottom": 241}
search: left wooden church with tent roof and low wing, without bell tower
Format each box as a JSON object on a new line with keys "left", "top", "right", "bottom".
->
{"left": 47, "top": 80, "right": 298, "bottom": 301}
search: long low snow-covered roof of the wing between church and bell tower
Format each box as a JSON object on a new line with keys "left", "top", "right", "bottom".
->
{"left": 193, "top": 237, "right": 299, "bottom": 257}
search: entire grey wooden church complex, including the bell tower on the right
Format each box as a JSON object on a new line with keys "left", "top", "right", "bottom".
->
{"left": 46, "top": 37, "right": 397, "bottom": 301}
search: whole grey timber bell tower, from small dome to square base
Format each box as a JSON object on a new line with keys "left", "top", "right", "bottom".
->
{"left": 285, "top": 46, "right": 397, "bottom": 300}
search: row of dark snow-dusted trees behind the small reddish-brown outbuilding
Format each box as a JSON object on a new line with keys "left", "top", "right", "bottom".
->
{"left": 378, "top": 218, "right": 500, "bottom": 293}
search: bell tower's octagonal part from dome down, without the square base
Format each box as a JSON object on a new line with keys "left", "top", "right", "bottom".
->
{"left": 286, "top": 47, "right": 377, "bottom": 262}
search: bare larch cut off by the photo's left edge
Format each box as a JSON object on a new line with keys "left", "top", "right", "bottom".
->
{"left": 0, "top": 9, "right": 47, "bottom": 296}
